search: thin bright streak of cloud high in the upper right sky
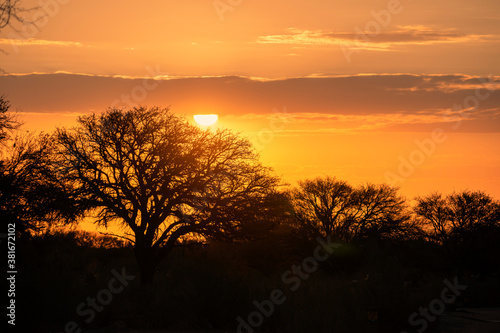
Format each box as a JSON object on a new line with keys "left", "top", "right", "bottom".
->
{"left": 257, "top": 26, "right": 493, "bottom": 51}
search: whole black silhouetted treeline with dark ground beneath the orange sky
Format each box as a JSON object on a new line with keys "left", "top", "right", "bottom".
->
{"left": 0, "top": 99, "right": 500, "bottom": 332}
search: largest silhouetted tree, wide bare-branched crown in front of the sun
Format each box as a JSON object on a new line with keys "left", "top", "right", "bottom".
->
{"left": 55, "top": 107, "right": 278, "bottom": 284}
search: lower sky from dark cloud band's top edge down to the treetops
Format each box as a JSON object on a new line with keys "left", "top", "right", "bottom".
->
{"left": 0, "top": 73, "right": 500, "bottom": 198}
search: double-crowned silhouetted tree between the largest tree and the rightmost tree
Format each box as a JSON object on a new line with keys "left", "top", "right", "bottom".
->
{"left": 291, "top": 177, "right": 408, "bottom": 242}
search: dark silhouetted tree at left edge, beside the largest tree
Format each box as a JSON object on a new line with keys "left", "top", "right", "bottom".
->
{"left": 0, "top": 134, "right": 83, "bottom": 235}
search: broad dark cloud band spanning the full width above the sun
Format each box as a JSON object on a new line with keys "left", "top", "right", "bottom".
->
{"left": 0, "top": 73, "right": 500, "bottom": 135}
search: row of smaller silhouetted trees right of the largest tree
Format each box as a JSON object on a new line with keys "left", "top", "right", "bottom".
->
{"left": 289, "top": 177, "right": 500, "bottom": 272}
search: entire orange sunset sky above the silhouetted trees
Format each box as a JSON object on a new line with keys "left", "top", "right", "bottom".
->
{"left": 0, "top": 0, "right": 500, "bottom": 202}
